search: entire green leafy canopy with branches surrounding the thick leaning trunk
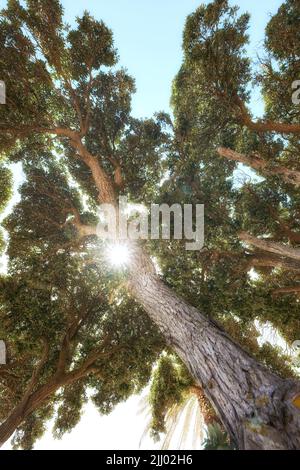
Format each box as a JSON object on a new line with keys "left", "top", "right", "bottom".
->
{"left": 0, "top": 0, "right": 300, "bottom": 449}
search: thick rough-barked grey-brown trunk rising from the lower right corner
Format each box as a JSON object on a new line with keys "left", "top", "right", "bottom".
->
{"left": 130, "top": 246, "right": 300, "bottom": 450}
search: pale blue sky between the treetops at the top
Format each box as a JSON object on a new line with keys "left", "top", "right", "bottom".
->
{"left": 62, "top": 0, "right": 282, "bottom": 117}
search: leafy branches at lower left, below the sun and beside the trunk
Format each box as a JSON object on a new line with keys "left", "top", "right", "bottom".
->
{"left": 0, "top": 159, "right": 163, "bottom": 449}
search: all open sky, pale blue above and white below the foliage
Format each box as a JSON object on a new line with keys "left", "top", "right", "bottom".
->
{"left": 0, "top": 0, "right": 282, "bottom": 449}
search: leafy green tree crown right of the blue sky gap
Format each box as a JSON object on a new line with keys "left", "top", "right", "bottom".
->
{"left": 173, "top": 2, "right": 299, "bottom": 342}
